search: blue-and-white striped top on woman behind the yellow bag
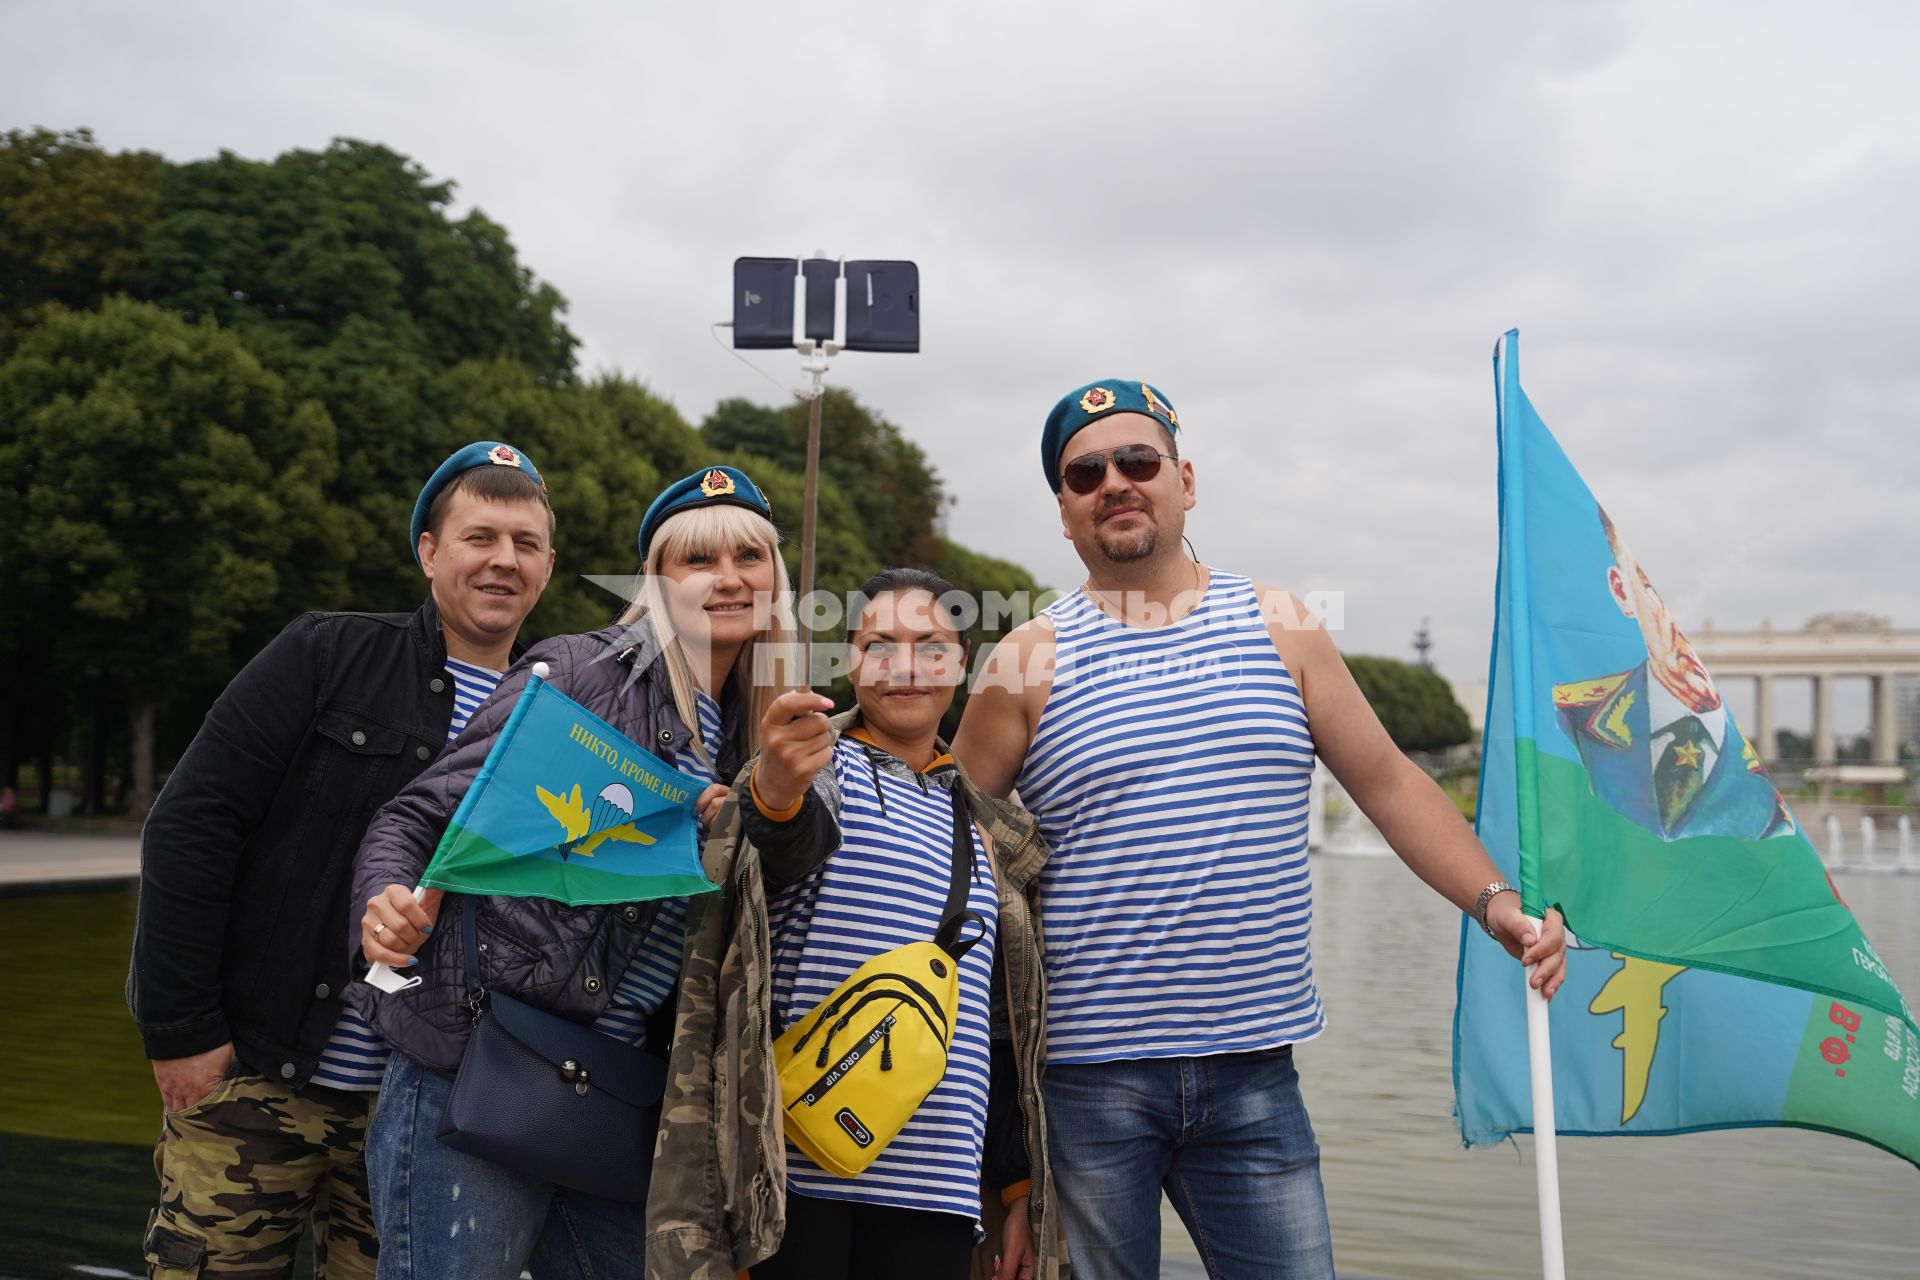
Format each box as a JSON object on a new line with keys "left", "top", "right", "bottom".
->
{"left": 768, "top": 737, "right": 1000, "bottom": 1224}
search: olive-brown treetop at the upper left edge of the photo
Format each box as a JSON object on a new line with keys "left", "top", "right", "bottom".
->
{"left": 0, "top": 129, "right": 167, "bottom": 355}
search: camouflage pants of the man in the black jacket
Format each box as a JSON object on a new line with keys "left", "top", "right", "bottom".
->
{"left": 146, "top": 1075, "right": 376, "bottom": 1280}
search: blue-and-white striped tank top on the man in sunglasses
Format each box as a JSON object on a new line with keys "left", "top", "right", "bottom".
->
{"left": 1016, "top": 572, "right": 1325, "bottom": 1063}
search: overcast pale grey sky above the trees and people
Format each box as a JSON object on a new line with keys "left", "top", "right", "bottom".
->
{"left": 0, "top": 0, "right": 1920, "bottom": 731}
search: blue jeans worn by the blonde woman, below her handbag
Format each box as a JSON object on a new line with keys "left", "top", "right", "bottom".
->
{"left": 367, "top": 1054, "right": 647, "bottom": 1280}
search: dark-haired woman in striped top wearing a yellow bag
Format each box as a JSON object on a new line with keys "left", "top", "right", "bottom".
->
{"left": 741, "top": 568, "right": 1058, "bottom": 1280}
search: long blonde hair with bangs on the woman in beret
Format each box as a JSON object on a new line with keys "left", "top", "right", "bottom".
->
{"left": 620, "top": 505, "right": 801, "bottom": 759}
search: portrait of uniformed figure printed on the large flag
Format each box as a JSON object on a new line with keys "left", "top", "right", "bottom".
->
{"left": 1553, "top": 507, "right": 1793, "bottom": 841}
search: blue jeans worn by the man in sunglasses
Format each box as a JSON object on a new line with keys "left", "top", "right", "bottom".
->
{"left": 1044, "top": 1048, "right": 1332, "bottom": 1280}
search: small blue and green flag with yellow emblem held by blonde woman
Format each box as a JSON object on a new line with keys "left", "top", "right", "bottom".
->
{"left": 420, "top": 674, "right": 718, "bottom": 906}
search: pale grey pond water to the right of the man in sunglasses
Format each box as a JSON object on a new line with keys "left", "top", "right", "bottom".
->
{"left": 1290, "top": 856, "right": 1920, "bottom": 1280}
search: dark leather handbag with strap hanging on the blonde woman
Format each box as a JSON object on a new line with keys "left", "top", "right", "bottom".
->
{"left": 438, "top": 898, "right": 666, "bottom": 1201}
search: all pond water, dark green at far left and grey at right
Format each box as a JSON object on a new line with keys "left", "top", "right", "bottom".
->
{"left": 0, "top": 856, "right": 1920, "bottom": 1280}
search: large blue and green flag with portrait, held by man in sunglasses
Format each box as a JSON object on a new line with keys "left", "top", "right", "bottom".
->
{"left": 1453, "top": 330, "right": 1920, "bottom": 1163}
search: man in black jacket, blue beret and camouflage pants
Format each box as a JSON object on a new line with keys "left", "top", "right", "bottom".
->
{"left": 127, "top": 441, "right": 553, "bottom": 1280}
